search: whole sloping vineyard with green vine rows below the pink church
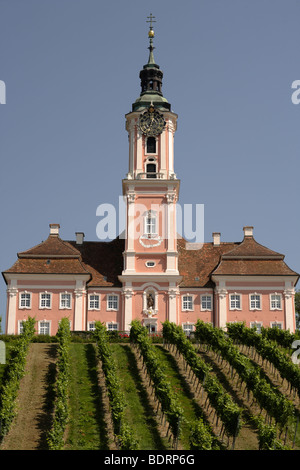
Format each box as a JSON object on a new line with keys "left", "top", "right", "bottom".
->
{"left": 0, "top": 318, "right": 300, "bottom": 451}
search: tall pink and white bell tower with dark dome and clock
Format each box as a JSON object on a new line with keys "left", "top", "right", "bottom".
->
{"left": 120, "top": 14, "right": 181, "bottom": 330}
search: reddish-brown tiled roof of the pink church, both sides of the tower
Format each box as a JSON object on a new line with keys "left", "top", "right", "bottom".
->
{"left": 3, "top": 231, "right": 298, "bottom": 288}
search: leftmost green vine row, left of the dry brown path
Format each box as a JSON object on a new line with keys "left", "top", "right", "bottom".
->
{"left": 0, "top": 317, "right": 35, "bottom": 440}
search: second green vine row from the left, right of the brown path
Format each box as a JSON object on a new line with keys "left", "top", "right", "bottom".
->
{"left": 47, "top": 318, "right": 71, "bottom": 450}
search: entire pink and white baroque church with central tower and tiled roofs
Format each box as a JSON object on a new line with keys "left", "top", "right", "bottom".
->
{"left": 2, "top": 15, "right": 299, "bottom": 335}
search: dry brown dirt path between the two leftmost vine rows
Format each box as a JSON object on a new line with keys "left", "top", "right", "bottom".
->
{"left": 0, "top": 343, "right": 56, "bottom": 450}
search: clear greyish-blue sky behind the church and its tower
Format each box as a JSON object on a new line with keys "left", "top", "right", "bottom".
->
{"left": 0, "top": 0, "right": 300, "bottom": 327}
